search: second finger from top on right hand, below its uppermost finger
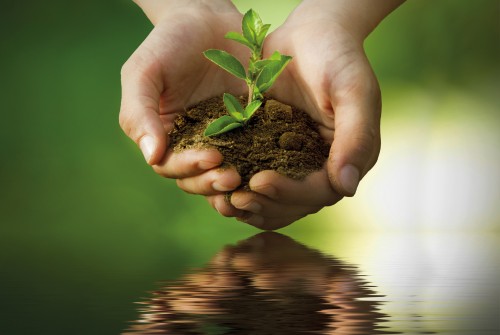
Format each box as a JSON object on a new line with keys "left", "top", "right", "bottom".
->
{"left": 231, "top": 191, "right": 323, "bottom": 219}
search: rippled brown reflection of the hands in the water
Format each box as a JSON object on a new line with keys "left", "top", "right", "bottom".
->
{"left": 125, "top": 232, "right": 402, "bottom": 335}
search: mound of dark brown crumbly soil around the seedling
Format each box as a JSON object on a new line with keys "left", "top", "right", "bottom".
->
{"left": 170, "top": 97, "right": 330, "bottom": 189}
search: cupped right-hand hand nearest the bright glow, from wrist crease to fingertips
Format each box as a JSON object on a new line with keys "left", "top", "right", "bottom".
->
{"left": 202, "top": 6, "right": 381, "bottom": 230}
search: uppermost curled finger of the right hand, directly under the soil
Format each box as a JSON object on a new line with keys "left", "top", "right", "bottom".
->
{"left": 250, "top": 169, "right": 342, "bottom": 207}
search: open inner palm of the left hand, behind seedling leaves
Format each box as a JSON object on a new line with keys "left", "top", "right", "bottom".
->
{"left": 132, "top": 11, "right": 245, "bottom": 124}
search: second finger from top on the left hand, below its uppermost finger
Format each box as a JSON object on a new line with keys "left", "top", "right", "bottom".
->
{"left": 177, "top": 169, "right": 241, "bottom": 195}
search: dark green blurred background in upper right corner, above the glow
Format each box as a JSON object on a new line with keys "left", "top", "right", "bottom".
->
{"left": 366, "top": 0, "right": 500, "bottom": 99}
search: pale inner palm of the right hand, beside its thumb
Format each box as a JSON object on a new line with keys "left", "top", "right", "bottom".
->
{"left": 266, "top": 22, "right": 376, "bottom": 142}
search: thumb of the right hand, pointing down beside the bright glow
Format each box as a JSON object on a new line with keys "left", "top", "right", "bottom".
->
{"left": 328, "top": 62, "right": 381, "bottom": 196}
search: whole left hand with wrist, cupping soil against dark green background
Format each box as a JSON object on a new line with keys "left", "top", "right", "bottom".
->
{"left": 120, "top": 0, "right": 248, "bottom": 194}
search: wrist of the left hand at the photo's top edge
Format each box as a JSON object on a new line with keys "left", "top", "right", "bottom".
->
{"left": 133, "top": 0, "right": 236, "bottom": 25}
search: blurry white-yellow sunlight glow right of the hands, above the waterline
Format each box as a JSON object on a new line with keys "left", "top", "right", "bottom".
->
{"left": 323, "top": 89, "right": 500, "bottom": 231}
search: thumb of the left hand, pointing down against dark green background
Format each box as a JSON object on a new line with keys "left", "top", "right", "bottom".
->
{"left": 119, "top": 58, "right": 167, "bottom": 165}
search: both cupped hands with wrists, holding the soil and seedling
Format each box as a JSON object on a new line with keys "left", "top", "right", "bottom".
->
{"left": 120, "top": 0, "right": 403, "bottom": 230}
